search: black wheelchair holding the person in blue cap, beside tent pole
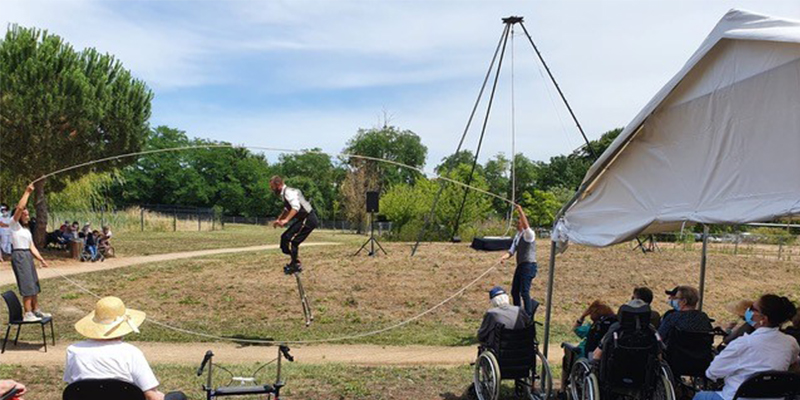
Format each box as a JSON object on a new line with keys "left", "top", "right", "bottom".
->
{"left": 473, "top": 323, "right": 553, "bottom": 400}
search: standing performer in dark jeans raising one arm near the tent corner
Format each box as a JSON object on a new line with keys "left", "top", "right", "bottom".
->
{"left": 500, "top": 204, "right": 539, "bottom": 318}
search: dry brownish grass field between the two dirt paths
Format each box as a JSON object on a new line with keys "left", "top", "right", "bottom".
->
{"left": 7, "top": 242, "right": 800, "bottom": 345}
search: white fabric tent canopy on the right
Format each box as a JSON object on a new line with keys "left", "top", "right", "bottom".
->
{"left": 553, "top": 10, "right": 800, "bottom": 246}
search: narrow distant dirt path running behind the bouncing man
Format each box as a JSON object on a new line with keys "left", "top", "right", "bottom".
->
{"left": 0, "top": 242, "right": 339, "bottom": 285}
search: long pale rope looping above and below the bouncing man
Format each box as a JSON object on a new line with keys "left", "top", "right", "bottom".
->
{"left": 31, "top": 144, "right": 515, "bottom": 345}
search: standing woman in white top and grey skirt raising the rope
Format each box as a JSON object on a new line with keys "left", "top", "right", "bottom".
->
{"left": 9, "top": 184, "right": 50, "bottom": 322}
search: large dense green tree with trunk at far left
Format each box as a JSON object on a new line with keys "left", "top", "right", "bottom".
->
{"left": 0, "top": 25, "right": 153, "bottom": 246}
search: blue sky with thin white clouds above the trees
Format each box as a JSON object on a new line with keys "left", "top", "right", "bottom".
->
{"left": 0, "top": 0, "right": 800, "bottom": 170}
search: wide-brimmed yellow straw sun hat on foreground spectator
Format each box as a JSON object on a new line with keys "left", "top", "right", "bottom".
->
{"left": 75, "top": 296, "right": 145, "bottom": 339}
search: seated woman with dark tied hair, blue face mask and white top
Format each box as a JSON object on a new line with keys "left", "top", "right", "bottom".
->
{"left": 694, "top": 294, "right": 800, "bottom": 400}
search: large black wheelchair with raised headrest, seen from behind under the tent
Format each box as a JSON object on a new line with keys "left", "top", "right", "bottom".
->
{"left": 568, "top": 306, "right": 675, "bottom": 400}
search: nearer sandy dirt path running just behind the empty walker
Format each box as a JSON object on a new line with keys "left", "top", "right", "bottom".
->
{"left": 0, "top": 342, "right": 561, "bottom": 367}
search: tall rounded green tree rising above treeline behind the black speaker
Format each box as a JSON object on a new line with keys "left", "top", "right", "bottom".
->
{"left": 344, "top": 126, "right": 428, "bottom": 189}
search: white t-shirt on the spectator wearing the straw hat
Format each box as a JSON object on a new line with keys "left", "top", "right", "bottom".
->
{"left": 64, "top": 340, "right": 158, "bottom": 392}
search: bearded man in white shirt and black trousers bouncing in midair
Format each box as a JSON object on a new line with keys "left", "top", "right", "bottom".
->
{"left": 269, "top": 175, "right": 319, "bottom": 275}
